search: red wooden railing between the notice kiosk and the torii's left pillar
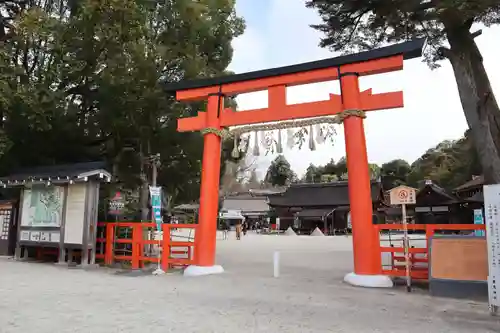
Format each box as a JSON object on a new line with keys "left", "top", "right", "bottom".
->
{"left": 96, "top": 222, "right": 197, "bottom": 270}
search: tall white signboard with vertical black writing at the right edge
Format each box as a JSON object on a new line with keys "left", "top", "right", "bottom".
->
{"left": 484, "top": 184, "right": 500, "bottom": 311}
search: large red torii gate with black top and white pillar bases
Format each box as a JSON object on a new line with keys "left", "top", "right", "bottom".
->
{"left": 165, "top": 39, "right": 425, "bottom": 287}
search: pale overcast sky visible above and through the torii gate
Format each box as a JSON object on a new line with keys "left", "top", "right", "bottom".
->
{"left": 230, "top": 0, "right": 500, "bottom": 176}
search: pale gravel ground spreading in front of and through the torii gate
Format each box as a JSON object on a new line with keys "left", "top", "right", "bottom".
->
{"left": 0, "top": 235, "right": 500, "bottom": 333}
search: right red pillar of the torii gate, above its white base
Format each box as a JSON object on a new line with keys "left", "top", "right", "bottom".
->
{"left": 340, "top": 73, "right": 382, "bottom": 275}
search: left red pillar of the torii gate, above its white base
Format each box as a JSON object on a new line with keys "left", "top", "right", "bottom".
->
{"left": 194, "top": 94, "right": 224, "bottom": 266}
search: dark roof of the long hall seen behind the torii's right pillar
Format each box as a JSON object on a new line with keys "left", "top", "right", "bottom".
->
{"left": 269, "top": 181, "right": 383, "bottom": 207}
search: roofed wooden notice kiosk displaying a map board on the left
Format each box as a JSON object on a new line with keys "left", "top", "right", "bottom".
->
{"left": 0, "top": 162, "right": 111, "bottom": 266}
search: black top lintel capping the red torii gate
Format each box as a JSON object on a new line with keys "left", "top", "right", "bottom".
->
{"left": 164, "top": 38, "right": 426, "bottom": 92}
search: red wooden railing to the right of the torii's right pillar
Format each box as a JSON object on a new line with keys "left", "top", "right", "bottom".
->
{"left": 375, "top": 224, "right": 485, "bottom": 280}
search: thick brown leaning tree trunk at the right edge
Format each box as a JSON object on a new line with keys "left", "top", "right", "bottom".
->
{"left": 446, "top": 25, "right": 500, "bottom": 184}
